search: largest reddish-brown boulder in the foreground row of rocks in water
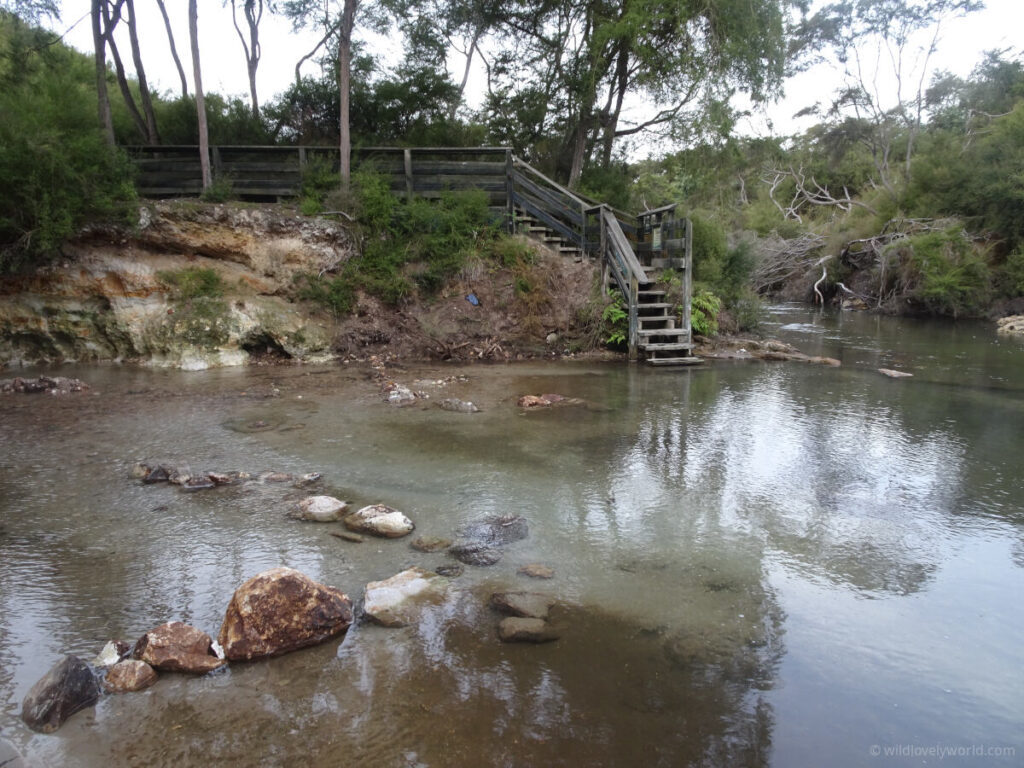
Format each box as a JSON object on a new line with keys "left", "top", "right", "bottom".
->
{"left": 217, "top": 567, "right": 352, "bottom": 662}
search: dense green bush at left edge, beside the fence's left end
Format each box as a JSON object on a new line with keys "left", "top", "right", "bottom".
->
{"left": 0, "top": 12, "right": 135, "bottom": 273}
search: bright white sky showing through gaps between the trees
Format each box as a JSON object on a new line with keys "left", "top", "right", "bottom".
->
{"left": 53, "top": 0, "right": 1024, "bottom": 141}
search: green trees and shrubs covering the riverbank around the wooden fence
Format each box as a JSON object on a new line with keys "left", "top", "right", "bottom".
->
{"left": 0, "top": 0, "right": 1024, "bottom": 330}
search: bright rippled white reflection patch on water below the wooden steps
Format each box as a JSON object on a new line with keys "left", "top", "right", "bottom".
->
{"left": 622, "top": 369, "right": 965, "bottom": 594}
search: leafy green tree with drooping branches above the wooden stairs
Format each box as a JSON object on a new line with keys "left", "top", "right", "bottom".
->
{"left": 479, "top": 0, "right": 790, "bottom": 186}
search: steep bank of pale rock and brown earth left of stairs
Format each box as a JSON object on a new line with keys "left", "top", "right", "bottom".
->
{"left": 0, "top": 201, "right": 596, "bottom": 369}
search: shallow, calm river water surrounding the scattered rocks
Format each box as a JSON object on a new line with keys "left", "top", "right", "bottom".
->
{"left": 0, "top": 306, "right": 1024, "bottom": 768}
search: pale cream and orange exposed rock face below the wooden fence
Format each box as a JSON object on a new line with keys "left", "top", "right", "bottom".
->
{"left": 0, "top": 203, "right": 344, "bottom": 370}
